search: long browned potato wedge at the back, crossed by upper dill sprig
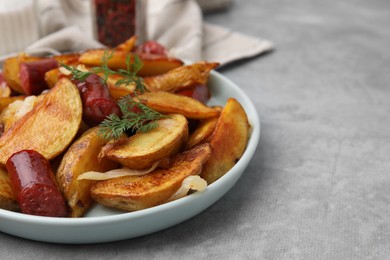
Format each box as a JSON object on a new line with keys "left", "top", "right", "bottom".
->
{"left": 79, "top": 49, "right": 183, "bottom": 77}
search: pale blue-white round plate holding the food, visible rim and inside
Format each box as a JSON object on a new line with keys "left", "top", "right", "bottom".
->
{"left": 0, "top": 72, "right": 260, "bottom": 244}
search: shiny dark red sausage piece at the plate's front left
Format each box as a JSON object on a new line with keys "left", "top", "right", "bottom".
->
{"left": 6, "top": 150, "right": 68, "bottom": 217}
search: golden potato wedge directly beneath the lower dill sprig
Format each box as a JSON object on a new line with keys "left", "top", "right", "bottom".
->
{"left": 100, "top": 114, "right": 188, "bottom": 170}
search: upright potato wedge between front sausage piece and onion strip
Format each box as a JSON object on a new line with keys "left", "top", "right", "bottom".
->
{"left": 56, "top": 127, "right": 118, "bottom": 217}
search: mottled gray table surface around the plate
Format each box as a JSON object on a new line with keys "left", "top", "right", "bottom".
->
{"left": 0, "top": 0, "right": 390, "bottom": 259}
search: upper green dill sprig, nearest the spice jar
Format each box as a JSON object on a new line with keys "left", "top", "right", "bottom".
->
{"left": 92, "top": 50, "right": 146, "bottom": 94}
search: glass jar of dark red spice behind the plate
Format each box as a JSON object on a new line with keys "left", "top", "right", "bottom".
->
{"left": 92, "top": 0, "right": 146, "bottom": 47}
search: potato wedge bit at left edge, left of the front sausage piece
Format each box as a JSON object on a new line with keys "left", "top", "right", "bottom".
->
{"left": 0, "top": 168, "right": 19, "bottom": 211}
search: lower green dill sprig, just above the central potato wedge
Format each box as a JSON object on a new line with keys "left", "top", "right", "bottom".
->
{"left": 99, "top": 95, "right": 168, "bottom": 140}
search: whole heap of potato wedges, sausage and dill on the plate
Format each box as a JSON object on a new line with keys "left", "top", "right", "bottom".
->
{"left": 0, "top": 37, "right": 250, "bottom": 217}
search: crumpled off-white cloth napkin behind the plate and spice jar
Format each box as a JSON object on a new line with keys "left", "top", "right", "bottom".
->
{"left": 0, "top": 0, "right": 273, "bottom": 65}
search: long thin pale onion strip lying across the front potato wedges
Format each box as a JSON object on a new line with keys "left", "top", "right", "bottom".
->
{"left": 77, "top": 162, "right": 159, "bottom": 181}
